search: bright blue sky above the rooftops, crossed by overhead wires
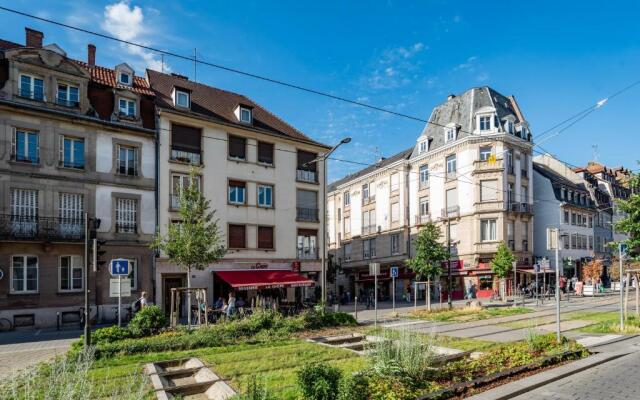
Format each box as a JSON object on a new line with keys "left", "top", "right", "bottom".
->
{"left": 0, "top": 0, "right": 640, "bottom": 179}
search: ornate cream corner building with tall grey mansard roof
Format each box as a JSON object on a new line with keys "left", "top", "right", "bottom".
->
{"left": 328, "top": 87, "right": 533, "bottom": 298}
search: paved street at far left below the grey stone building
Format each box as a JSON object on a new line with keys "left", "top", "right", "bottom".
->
{"left": 0, "top": 330, "right": 82, "bottom": 380}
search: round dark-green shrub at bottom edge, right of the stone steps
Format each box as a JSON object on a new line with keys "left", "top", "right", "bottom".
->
{"left": 298, "top": 364, "right": 342, "bottom": 400}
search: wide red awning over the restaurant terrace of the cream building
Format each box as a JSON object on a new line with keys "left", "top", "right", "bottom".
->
{"left": 215, "top": 270, "right": 314, "bottom": 290}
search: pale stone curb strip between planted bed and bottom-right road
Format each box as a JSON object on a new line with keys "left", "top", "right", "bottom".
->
{"left": 465, "top": 352, "right": 631, "bottom": 400}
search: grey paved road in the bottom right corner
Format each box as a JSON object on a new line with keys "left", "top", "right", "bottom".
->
{"left": 514, "top": 351, "right": 640, "bottom": 400}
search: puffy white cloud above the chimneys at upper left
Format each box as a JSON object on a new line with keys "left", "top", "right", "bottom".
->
{"left": 101, "top": 0, "right": 170, "bottom": 71}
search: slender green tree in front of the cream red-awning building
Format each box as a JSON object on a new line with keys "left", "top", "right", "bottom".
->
{"left": 151, "top": 169, "right": 226, "bottom": 327}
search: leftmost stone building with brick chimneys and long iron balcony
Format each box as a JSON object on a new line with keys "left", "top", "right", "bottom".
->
{"left": 0, "top": 28, "right": 155, "bottom": 327}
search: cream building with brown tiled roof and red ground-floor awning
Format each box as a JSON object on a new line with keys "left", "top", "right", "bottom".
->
{"left": 147, "top": 70, "right": 328, "bottom": 310}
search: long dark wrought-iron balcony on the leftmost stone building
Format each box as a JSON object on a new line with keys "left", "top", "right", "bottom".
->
{"left": 0, "top": 214, "right": 84, "bottom": 242}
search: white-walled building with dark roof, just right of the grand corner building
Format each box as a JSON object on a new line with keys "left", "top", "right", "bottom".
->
{"left": 533, "top": 155, "right": 605, "bottom": 279}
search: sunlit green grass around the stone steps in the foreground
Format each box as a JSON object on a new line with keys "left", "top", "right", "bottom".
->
{"left": 90, "top": 339, "right": 365, "bottom": 400}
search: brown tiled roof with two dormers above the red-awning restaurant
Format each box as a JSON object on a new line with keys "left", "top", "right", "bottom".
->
{"left": 147, "top": 69, "right": 327, "bottom": 147}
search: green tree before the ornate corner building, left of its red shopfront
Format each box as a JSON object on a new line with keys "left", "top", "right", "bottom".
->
{"left": 406, "top": 222, "right": 449, "bottom": 311}
